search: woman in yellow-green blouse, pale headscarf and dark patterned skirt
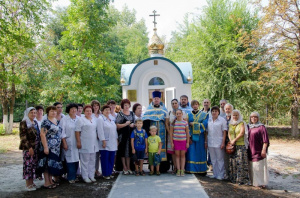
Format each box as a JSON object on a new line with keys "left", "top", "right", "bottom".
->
{"left": 228, "top": 110, "right": 249, "bottom": 185}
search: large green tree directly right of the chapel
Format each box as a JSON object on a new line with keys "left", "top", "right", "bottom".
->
{"left": 166, "top": 0, "right": 260, "bottom": 111}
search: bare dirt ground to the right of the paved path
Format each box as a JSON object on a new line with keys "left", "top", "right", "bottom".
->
{"left": 196, "top": 139, "right": 300, "bottom": 198}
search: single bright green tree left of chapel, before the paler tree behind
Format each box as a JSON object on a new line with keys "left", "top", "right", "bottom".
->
{"left": 35, "top": 0, "right": 120, "bottom": 102}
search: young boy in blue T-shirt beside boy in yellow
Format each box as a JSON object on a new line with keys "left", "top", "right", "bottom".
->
{"left": 130, "top": 118, "right": 148, "bottom": 176}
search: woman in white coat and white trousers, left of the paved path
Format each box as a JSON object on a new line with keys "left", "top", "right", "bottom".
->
{"left": 75, "top": 105, "right": 99, "bottom": 183}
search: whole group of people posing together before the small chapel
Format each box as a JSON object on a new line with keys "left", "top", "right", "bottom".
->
{"left": 20, "top": 91, "right": 269, "bottom": 191}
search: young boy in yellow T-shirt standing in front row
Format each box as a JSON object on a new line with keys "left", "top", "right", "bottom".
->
{"left": 148, "top": 126, "right": 162, "bottom": 176}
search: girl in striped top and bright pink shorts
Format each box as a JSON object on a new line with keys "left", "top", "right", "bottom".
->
{"left": 170, "top": 109, "right": 189, "bottom": 176}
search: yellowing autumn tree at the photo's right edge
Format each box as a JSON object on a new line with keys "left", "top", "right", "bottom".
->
{"left": 250, "top": 0, "right": 300, "bottom": 136}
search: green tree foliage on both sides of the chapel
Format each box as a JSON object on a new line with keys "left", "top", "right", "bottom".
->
{"left": 0, "top": 0, "right": 298, "bottom": 128}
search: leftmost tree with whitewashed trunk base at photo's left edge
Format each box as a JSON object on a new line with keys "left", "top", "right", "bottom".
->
{"left": 0, "top": 0, "right": 49, "bottom": 134}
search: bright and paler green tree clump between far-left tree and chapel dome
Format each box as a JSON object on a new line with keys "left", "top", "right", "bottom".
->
{"left": 10, "top": 0, "right": 148, "bottom": 108}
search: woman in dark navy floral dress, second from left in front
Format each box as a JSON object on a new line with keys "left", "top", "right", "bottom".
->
{"left": 38, "top": 106, "right": 63, "bottom": 188}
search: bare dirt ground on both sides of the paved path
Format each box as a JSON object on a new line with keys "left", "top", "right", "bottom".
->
{"left": 0, "top": 136, "right": 300, "bottom": 198}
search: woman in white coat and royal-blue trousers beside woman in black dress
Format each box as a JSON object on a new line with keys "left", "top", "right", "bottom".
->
{"left": 97, "top": 105, "right": 118, "bottom": 179}
